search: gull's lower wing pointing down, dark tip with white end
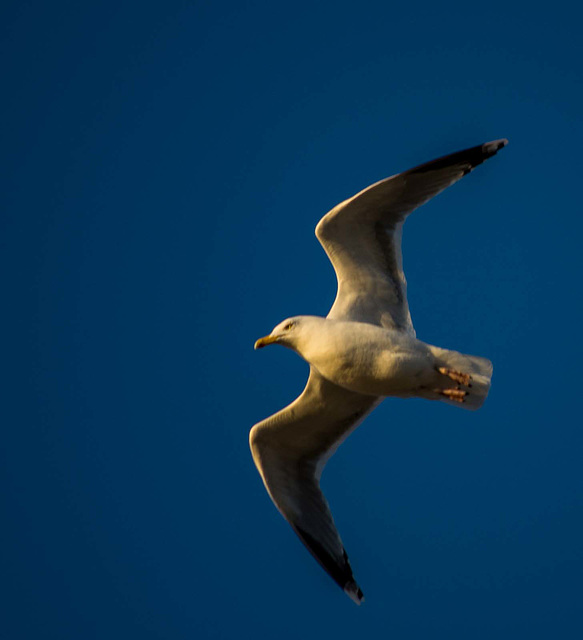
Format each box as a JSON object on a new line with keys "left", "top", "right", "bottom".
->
{"left": 249, "top": 369, "right": 380, "bottom": 604}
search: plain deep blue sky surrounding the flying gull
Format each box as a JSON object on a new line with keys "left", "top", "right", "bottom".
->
{"left": 0, "top": 0, "right": 583, "bottom": 640}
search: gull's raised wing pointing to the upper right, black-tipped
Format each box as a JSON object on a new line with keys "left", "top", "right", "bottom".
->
{"left": 316, "top": 140, "right": 508, "bottom": 335}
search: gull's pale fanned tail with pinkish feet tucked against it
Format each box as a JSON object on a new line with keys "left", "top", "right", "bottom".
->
{"left": 431, "top": 346, "right": 493, "bottom": 411}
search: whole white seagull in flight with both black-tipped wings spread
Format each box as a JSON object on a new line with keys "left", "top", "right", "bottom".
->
{"left": 249, "top": 139, "right": 508, "bottom": 604}
